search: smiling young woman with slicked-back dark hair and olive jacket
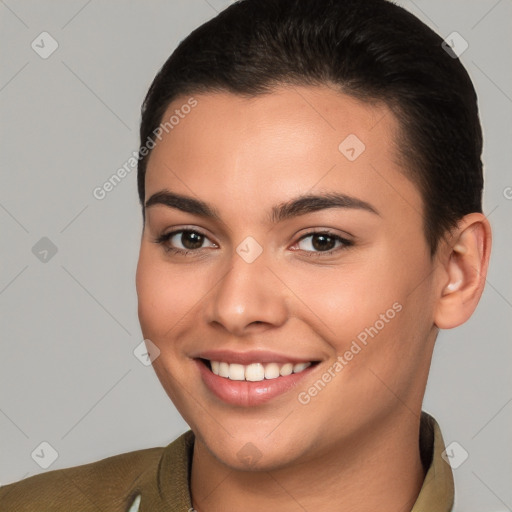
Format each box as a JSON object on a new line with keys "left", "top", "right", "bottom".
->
{"left": 0, "top": 0, "right": 491, "bottom": 512}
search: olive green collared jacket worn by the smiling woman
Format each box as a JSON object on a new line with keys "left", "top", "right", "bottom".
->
{"left": 0, "top": 412, "right": 454, "bottom": 512}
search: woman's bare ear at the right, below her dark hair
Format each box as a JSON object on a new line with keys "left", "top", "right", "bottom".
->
{"left": 434, "top": 213, "right": 492, "bottom": 329}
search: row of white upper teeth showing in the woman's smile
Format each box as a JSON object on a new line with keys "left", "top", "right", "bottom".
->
{"left": 210, "top": 361, "right": 311, "bottom": 382}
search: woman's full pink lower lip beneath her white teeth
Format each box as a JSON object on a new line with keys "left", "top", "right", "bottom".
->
{"left": 195, "top": 359, "right": 316, "bottom": 407}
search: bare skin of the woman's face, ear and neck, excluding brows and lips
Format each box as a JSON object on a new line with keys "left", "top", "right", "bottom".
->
{"left": 137, "top": 86, "right": 491, "bottom": 512}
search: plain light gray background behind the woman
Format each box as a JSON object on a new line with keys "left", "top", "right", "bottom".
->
{"left": 0, "top": 0, "right": 512, "bottom": 512}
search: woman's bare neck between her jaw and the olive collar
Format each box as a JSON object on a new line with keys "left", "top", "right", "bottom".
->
{"left": 191, "top": 408, "right": 425, "bottom": 512}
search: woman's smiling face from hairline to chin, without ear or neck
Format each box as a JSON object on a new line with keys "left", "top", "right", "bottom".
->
{"left": 137, "top": 86, "right": 444, "bottom": 469}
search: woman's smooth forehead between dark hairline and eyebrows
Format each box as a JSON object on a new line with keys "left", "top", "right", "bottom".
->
{"left": 146, "top": 86, "right": 420, "bottom": 224}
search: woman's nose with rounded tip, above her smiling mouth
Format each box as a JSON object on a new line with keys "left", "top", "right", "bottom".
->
{"left": 205, "top": 248, "right": 288, "bottom": 336}
